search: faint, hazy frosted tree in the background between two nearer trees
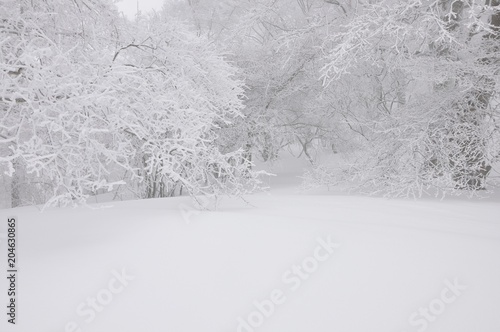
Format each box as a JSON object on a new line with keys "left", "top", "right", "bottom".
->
{"left": 166, "top": 0, "right": 348, "bottom": 161}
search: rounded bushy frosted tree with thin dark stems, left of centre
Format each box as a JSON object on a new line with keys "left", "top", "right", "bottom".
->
{"left": 115, "top": 11, "right": 257, "bottom": 197}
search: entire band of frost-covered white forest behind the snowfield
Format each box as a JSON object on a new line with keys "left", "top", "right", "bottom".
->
{"left": 0, "top": 0, "right": 500, "bottom": 208}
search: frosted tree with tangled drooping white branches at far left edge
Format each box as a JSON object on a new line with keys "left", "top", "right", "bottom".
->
{"left": 0, "top": 1, "right": 124, "bottom": 206}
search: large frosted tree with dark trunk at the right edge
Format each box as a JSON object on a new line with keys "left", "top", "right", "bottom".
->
{"left": 309, "top": 0, "right": 500, "bottom": 196}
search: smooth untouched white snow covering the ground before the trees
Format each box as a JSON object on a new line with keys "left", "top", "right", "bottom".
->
{"left": 0, "top": 151, "right": 500, "bottom": 332}
